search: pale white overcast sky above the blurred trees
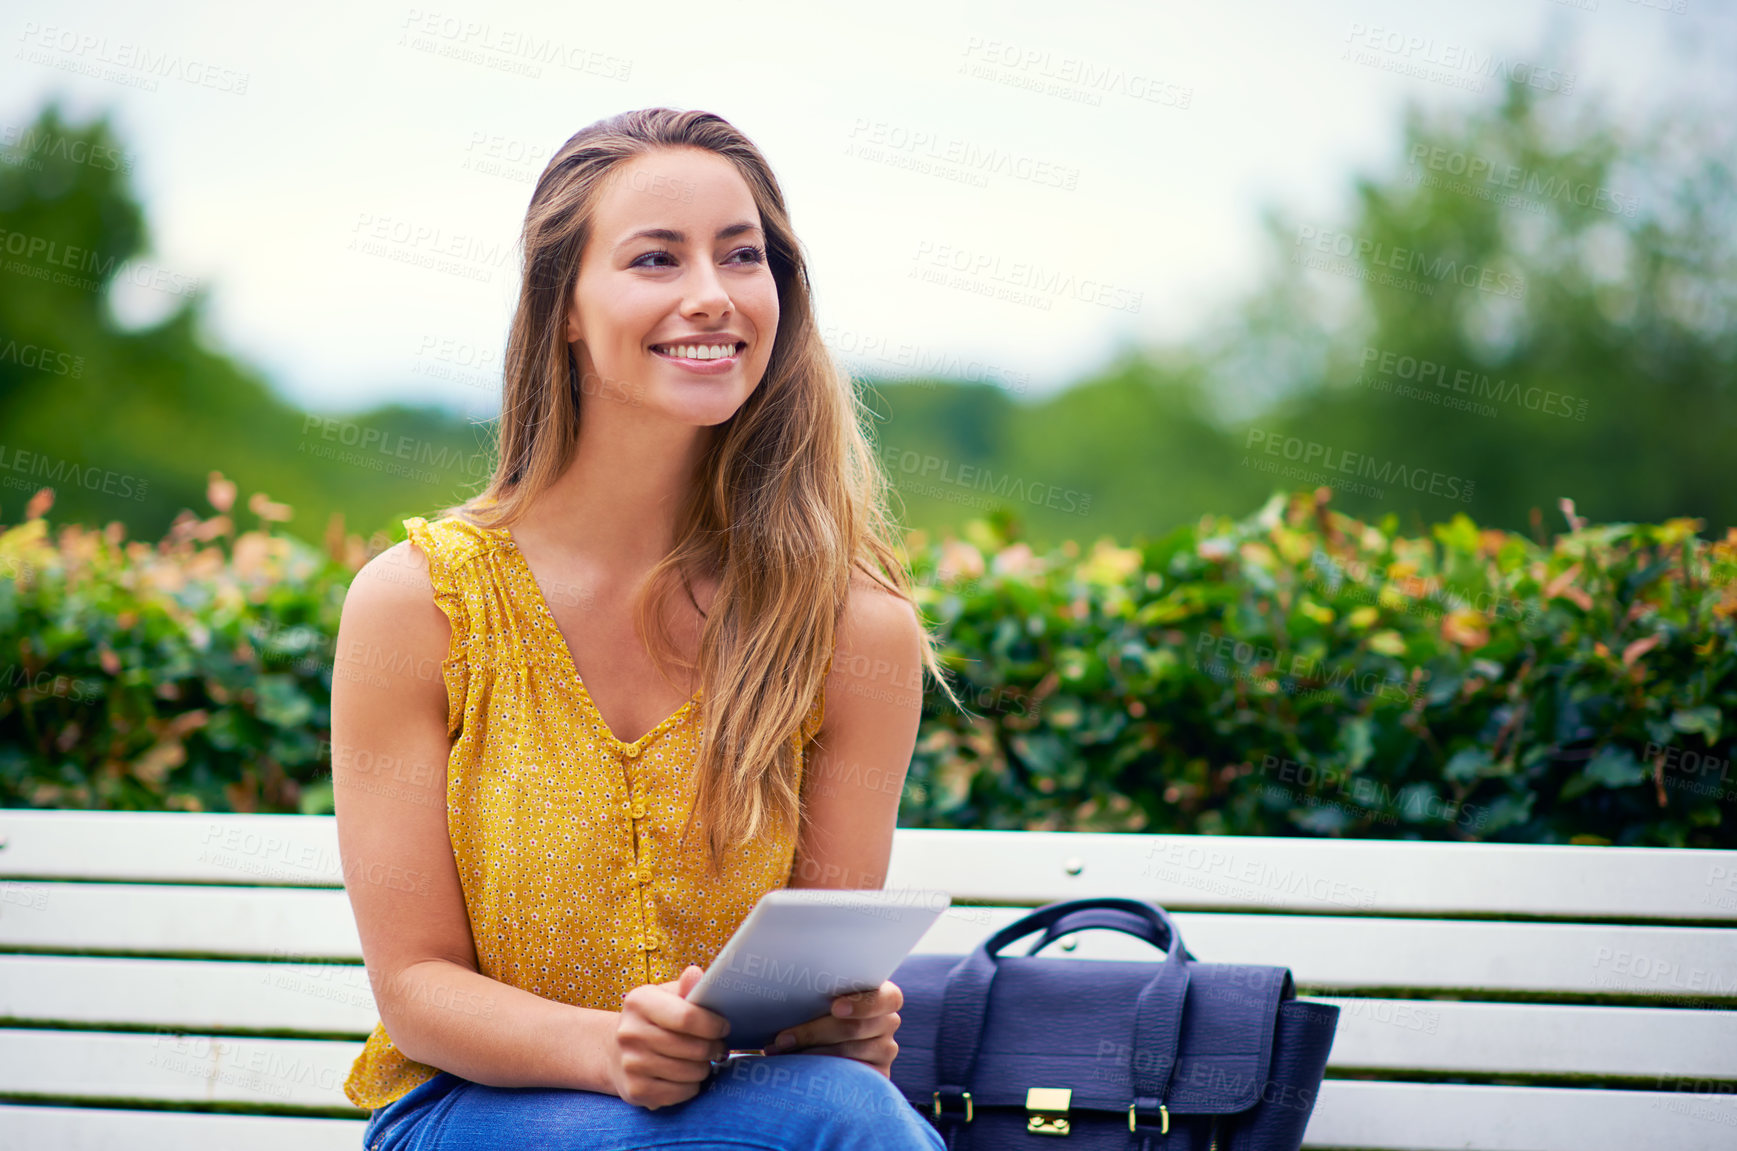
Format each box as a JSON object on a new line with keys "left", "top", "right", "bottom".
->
{"left": 0, "top": 0, "right": 1737, "bottom": 423}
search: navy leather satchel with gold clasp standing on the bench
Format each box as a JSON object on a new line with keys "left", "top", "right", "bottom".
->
{"left": 893, "top": 898, "right": 1339, "bottom": 1151}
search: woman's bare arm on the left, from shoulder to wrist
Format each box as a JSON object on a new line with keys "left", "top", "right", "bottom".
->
{"left": 332, "top": 542, "right": 618, "bottom": 1094}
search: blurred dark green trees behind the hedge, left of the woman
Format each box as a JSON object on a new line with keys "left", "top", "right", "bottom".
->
{"left": 0, "top": 102, "right": 488, "bottom": 542}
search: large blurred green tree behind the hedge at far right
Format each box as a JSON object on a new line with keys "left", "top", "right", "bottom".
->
{"left": 1214, "top": 85, "right": 1737, "bottom": 533}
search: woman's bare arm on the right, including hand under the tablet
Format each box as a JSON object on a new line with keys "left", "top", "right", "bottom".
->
{"left": 769, "top": 576, "right": 922, "bottom": 1075}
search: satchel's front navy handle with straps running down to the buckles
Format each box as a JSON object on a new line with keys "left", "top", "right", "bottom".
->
{"left": 935, "top": 896, "right": 1195, "bottom": 1118}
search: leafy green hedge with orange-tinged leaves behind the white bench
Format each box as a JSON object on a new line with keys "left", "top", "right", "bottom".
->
{"left": 0, "top": 479, "right": 1737, "bottom": 847}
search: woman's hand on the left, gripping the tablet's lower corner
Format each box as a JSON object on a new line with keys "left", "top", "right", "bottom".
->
{"left": 610, "top": 964, "right": 730, "bottom": 1111}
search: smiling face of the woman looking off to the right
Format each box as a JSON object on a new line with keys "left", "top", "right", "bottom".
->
{"left": 566, "top": 148, "right": 778, "bottom": 425}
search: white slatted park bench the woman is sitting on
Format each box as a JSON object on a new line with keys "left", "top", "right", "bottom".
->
{"left": 0, "top": 811, "right": 1737, "bottom": 1151}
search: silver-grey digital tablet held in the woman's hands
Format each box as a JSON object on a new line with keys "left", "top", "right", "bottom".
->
{"left": 688, "top": 887, "right": 954, "bottom": 1050}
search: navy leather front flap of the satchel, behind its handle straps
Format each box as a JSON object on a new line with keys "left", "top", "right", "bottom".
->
{"left": 893, "top": 955, "right": 1294, "bottom": 1115}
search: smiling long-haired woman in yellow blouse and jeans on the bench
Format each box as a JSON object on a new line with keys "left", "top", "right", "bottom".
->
{"left": 332, "top": 108, "right": 950, "bottom": 1151}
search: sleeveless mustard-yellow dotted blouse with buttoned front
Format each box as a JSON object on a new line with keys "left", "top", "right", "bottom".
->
{"left": 344, "top": 516, "right": 825, "bottom": 1109}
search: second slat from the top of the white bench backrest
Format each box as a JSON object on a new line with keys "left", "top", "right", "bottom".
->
{"left": 0, "top": 884, "right": 1737, "bottom": 1003}
